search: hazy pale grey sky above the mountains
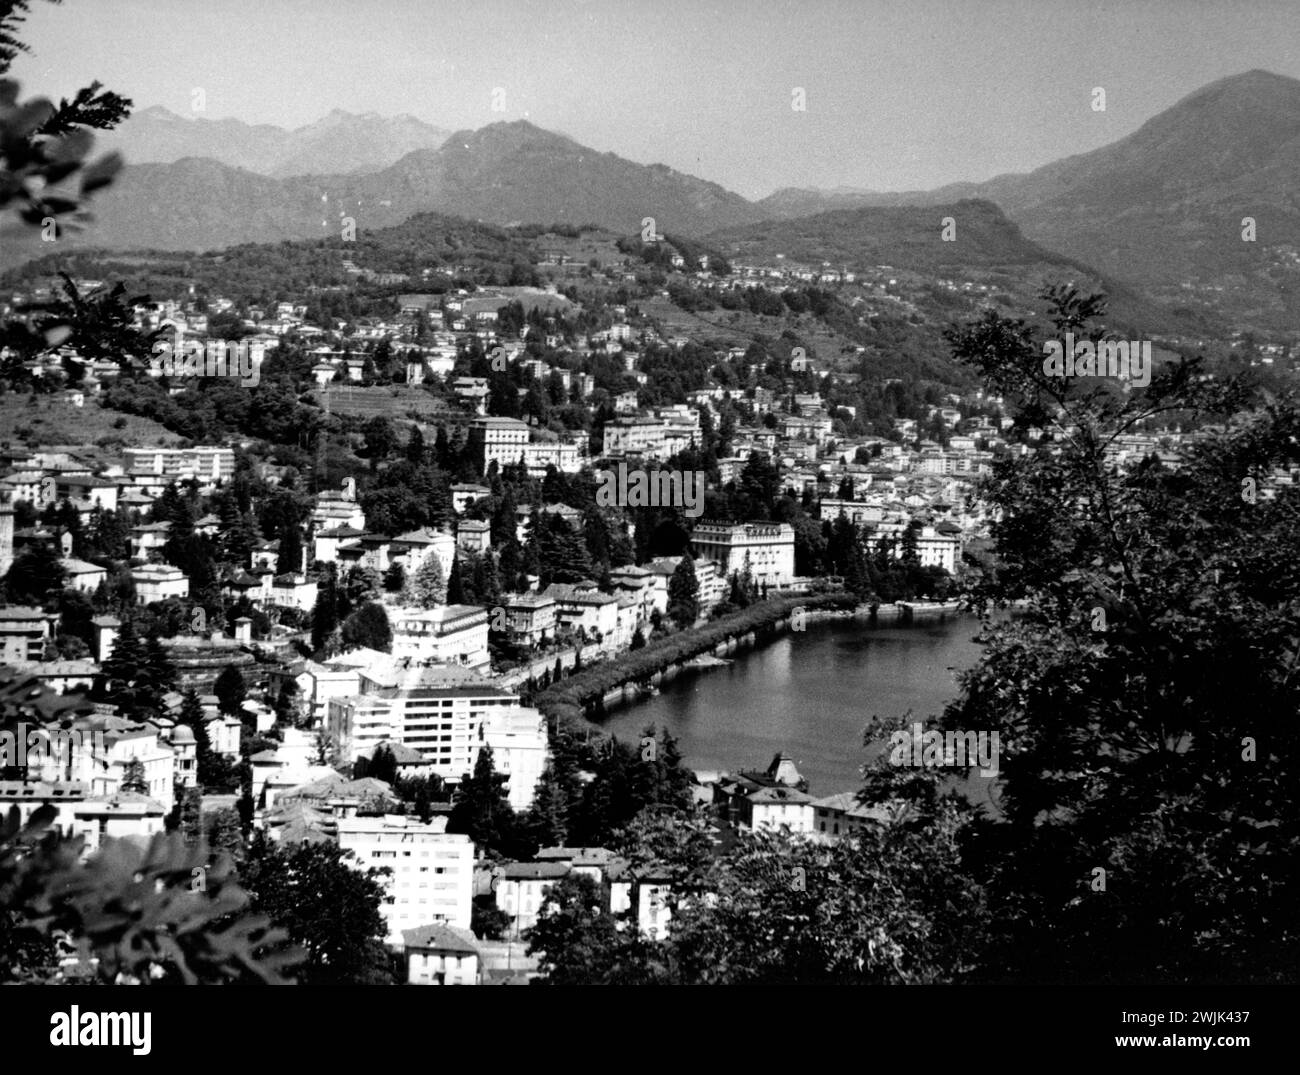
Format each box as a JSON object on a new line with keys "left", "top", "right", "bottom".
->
{"left": 12, "top": 0, "right": 1300, "bottom": 198}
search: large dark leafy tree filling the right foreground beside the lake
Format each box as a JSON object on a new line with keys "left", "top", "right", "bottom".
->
{"left": 925, "top": 289, "right": 1300, "bottom": 983}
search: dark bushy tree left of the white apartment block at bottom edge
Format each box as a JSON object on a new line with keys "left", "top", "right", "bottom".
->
{"left": 239, "top": 832, "right": 393, "bottom": 985}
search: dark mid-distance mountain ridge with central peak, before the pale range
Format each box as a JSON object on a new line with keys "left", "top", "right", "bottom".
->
{"left": 20, "top": 121, "right": 755, "bottom": 264}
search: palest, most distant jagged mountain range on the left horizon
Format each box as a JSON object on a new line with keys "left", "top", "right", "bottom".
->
{"left": 101, "top": 107, "right": 450, "bottom": 178}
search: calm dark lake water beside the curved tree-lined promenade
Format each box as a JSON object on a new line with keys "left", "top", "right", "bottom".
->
{"left": 602, "top": 615, "right": 987, "bottom": 799}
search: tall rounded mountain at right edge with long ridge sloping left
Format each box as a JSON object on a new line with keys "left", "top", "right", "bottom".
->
{"left": 758, "top": 70, "right": 1300, "bottom": 328}
